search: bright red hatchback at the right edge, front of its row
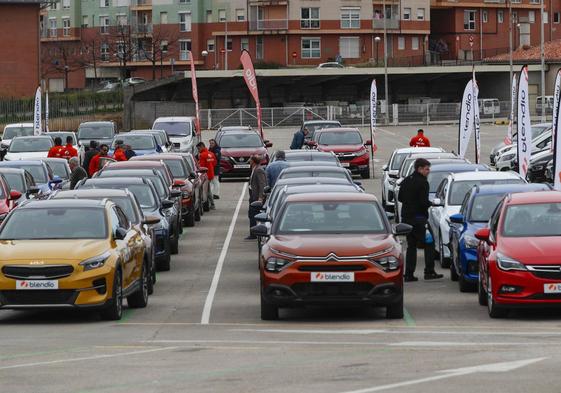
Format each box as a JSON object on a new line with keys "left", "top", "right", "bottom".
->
{"left": 475, "top": 191, "right": 561, "bottom": 318}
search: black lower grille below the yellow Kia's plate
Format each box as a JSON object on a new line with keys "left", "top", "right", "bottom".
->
{"left": 0, "top": 289, "right": 78, "bottom": 306}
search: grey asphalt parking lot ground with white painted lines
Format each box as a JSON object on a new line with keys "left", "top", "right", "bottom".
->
{"left": 0, "top": 125, "right": 561, "bottom": 393}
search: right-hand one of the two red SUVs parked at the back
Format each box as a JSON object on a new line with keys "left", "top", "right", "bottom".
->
{"left": 309, "top": 128, "right": 372, "bottom": 179}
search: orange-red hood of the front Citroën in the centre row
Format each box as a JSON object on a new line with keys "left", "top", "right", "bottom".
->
{"left": 268, "top": 234, "right": 395, "bottom": 257}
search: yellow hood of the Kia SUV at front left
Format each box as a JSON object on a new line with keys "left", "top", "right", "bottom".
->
{"left": 0, "top": 239, "right": 109, "bottom": 263}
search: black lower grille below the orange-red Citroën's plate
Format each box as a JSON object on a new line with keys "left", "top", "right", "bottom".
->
{"left": 292, "top": 282, "right": 372, "bottom": 298}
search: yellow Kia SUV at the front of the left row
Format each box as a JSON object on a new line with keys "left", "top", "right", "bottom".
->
{"left": 0, "top": 199, "right": 150, "bottom": 320}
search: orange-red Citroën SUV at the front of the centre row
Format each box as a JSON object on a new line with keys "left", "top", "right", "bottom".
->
{"left": 252, "top": 193, "right": 411, "bottom": 320}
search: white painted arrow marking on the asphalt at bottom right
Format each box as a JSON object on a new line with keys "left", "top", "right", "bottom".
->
{"left": 345, "top": 358, "right": 547, "bottom": 393}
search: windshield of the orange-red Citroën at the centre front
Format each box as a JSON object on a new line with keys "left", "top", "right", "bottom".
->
{"left": 277, "top": 202, "right": 386, "bottom": 234}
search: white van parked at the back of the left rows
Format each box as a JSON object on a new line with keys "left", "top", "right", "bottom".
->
{"left": 152, "top": 116, "right": 200, "bottom": 155}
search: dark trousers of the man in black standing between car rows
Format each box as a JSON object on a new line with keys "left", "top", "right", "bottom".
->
{"left": 403, "top": 217, "right": 434, "bottom": 277}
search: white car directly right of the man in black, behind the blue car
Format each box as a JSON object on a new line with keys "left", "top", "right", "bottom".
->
{"left": 428, "top": 171, "right": 526, "bottom": 268}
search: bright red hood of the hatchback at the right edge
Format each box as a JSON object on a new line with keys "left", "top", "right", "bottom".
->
{"left": 499, "top": 236, "right": 561, "bottom": 265}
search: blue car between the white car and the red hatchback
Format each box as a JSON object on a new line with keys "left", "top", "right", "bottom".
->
{"left": 450, "top": 184, "right": 551, "bottom": 292}
